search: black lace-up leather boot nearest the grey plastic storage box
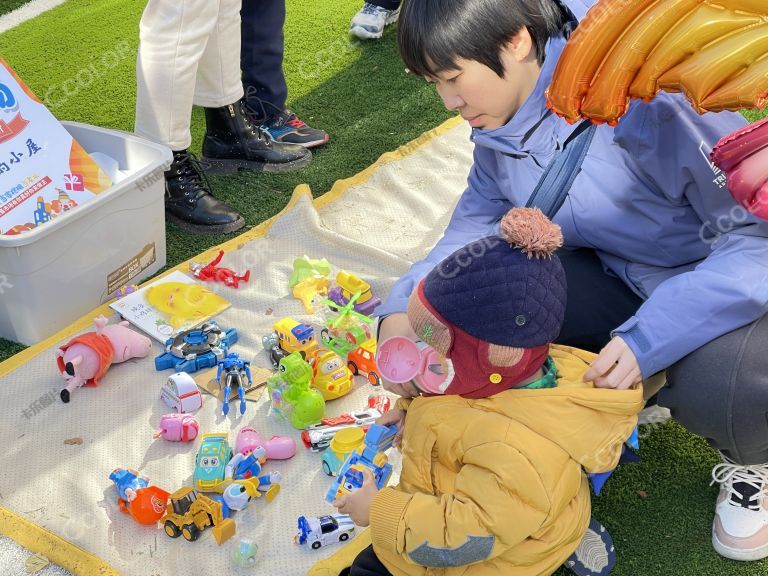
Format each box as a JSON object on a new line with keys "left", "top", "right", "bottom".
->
{"left": 165, "top": 150, "right": 245, "bottom": 234}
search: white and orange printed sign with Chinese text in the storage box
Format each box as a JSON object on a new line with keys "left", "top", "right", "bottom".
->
{"left": 0, "top": 59, "right": 112, "bottom": 234}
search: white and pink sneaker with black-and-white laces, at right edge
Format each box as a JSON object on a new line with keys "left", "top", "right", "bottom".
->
{"left": 712, "top": 457, "right": 768, "bottom": 560}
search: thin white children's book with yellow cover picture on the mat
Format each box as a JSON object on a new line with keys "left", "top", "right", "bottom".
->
{"left": 109, "top": 270, "right": 231, "bottom": 344}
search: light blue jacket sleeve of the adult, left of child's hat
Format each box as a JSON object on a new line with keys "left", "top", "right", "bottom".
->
{"left": 376, "top": 147, "right": 512, "bottom": 317}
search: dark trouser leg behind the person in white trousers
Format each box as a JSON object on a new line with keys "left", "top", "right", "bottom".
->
{"left": 240, "top": 0, "right": 288, "bottom": 116}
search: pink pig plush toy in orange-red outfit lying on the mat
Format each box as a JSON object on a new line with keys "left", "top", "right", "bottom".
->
{"left": 56, "top": 316, "right": 152, "bottom": 403}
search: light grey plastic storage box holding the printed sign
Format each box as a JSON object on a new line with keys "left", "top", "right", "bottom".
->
{"left": 0, "top": 122, "right": 172, "bottom": 345}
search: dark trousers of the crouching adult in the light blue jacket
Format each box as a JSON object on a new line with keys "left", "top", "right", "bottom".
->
{"left": 557, "top": 250, "right": 768, "bottom": 465}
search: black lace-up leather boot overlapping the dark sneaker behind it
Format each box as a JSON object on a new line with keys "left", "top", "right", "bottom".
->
{"left": 203, "top": 100, "right": 312, "bottom": 174}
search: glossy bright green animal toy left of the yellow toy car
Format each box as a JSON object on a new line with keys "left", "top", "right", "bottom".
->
{"left": 267, "top": 352, "right": 325, "bottom": 430}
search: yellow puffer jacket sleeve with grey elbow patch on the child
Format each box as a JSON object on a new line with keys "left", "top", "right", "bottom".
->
{"left": 371, "top": 442, "right": 550, "bottom": 568}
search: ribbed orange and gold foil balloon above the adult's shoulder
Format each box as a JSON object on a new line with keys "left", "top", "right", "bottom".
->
{"left": 547, "top": 0, "right": 768, "bottom": 124}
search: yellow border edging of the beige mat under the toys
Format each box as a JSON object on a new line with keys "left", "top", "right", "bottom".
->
{"left": 0, "top": 116, "right": 463, "bottom": 576}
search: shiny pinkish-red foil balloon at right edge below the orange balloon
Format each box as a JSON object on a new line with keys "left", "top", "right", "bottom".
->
{"left": 711, "top": 116, "right": 768, "bottom": 220}
